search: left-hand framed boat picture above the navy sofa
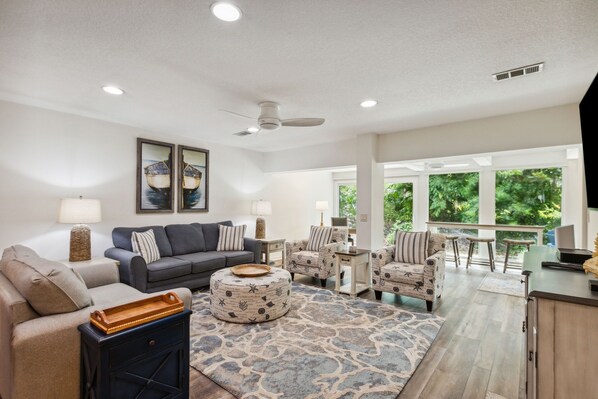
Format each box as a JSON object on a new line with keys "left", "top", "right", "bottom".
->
{"left": 136, "top": 138, "right": 175, "bottom": 213}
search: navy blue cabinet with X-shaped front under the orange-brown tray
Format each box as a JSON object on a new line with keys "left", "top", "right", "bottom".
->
{"left": 79, "top": 309, "right": 191, "bottom": 399}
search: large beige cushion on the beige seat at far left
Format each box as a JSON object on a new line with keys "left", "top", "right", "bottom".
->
{"left": 0, "top": 245, "right": 92, "bottom": 316}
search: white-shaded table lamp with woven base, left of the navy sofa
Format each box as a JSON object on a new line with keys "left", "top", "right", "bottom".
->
{"left": 58, "top": 197, "right": 102, "bottom": 262}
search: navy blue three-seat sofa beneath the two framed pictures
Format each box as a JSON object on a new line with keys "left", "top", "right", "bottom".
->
{"left": 104, "top": 220, "right": 261, "bottom": 292}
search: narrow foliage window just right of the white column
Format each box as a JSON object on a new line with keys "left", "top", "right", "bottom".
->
{"left": 384, "top": 183, "right": 413, "bottom": 244}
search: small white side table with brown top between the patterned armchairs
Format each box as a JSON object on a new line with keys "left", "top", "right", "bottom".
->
{"left": 334, "top": 249, "right": 372, "bottom": 297}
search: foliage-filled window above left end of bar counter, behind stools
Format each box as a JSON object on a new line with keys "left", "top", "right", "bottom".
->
{"left": 428, "top": 173, "right": 480, "bottom": 223}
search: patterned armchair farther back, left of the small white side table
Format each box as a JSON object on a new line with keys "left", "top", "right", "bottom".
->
{"left": 285, "top": 227, "right": 349, "bottom": 287}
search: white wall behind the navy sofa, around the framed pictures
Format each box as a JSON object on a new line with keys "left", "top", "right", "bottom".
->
{"left": 0, "top": 102, "right": 276, "bottom": 259}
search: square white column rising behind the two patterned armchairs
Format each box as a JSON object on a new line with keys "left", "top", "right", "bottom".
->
{"left": 356, "top": 133, "right": 384, "bottom": 250}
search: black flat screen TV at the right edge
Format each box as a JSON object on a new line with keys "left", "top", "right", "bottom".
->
{"left": 579, "top": 74, "right": 598, "bottom": 209}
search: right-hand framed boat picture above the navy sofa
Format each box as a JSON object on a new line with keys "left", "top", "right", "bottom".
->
{"left": 177, "top": 145, "right": 210, "bottom": 212}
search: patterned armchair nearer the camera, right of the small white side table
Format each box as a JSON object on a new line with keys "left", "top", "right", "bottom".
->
{"left": 372, "top": 233, "right": 446, "bottom": 311}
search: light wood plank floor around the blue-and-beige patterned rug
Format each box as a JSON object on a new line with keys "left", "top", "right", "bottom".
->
{"left": 190, "top": 260, "right": 525, "bottom": 399}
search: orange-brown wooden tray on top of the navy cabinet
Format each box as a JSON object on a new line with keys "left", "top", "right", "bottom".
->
{"left": 89, "top": 292, "right": 184, "bottom": 334}
